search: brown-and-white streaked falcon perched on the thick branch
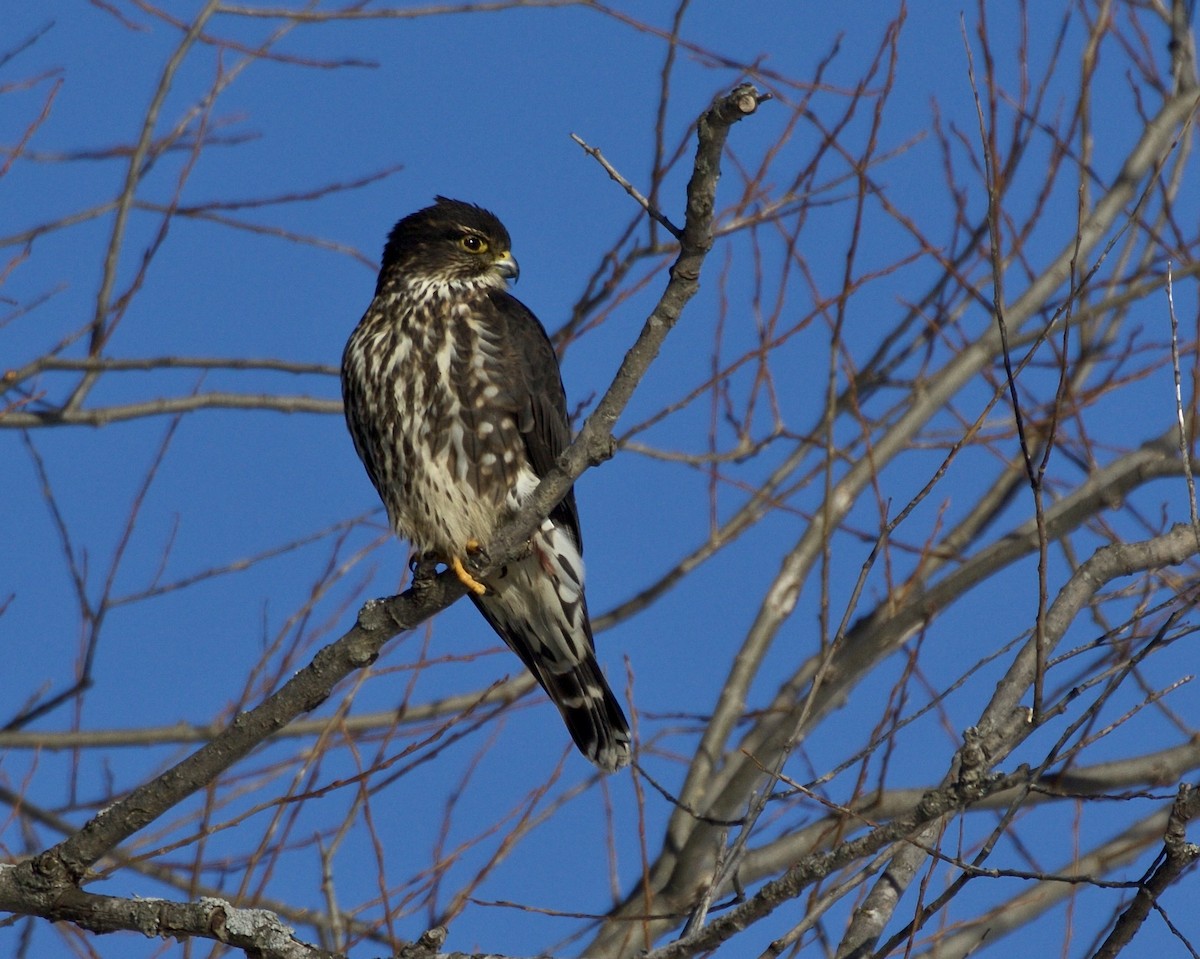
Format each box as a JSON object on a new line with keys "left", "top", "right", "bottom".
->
{"left": 342, "top": 197, "right": 630, "bottom": 771}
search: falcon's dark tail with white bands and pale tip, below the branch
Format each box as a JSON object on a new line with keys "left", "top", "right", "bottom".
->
{"left": 472, "top": 523, "right": 630, "bottom": 772}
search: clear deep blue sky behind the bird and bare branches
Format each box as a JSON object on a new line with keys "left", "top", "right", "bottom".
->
{"left": 0, "top": 0, "right": 1198, "bottom": 955}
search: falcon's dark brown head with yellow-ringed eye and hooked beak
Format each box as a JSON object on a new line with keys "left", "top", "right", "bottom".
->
{"left": 379, "top": 197, "right": 520, "bottom": 289}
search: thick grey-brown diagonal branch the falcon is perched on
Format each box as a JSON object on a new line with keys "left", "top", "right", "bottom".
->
{"left": 0, "top": 85, "right": 767, "bottom": 928}
